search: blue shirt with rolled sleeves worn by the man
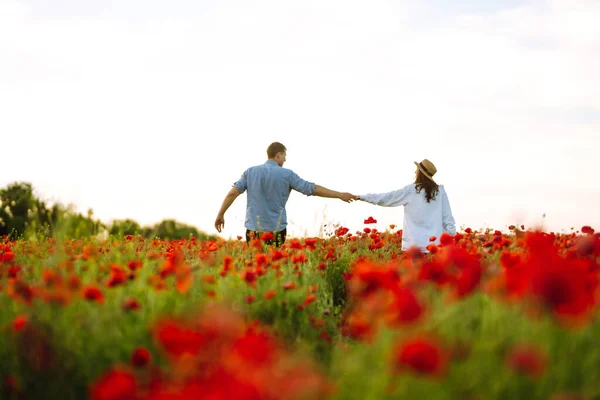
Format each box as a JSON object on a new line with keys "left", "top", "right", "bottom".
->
{"left": 233, "top": 160, "right": 316, "bottom": 232}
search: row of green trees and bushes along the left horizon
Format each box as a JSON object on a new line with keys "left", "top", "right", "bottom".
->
{"left": 0, "top": 182, "right": 215, "bottom": 240}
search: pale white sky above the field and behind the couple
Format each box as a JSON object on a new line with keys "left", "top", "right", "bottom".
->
{"left": 0, "top": 0, "right": 600, "bottom": 237}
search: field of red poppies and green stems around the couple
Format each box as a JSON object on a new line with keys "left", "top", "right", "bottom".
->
{"left": 0, "top": 217, "right": 600, "bottom": 400}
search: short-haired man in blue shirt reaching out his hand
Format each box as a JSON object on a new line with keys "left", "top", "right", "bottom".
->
{"left": 215, "top": 142, "right": 357, "bottom": 246}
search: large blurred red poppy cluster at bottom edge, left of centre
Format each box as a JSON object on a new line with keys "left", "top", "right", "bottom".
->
{"left": 142, "top": 305, "right": 331, "bottom": 400}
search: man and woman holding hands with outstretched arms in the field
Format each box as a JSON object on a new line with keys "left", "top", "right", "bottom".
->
{"left": 215, "top": 142, "right": 456, "bottom": 251}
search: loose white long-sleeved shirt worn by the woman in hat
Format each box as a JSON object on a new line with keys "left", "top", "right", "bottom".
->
{"left": 360, "top": 183, "right": 456, "bottom": 251}
